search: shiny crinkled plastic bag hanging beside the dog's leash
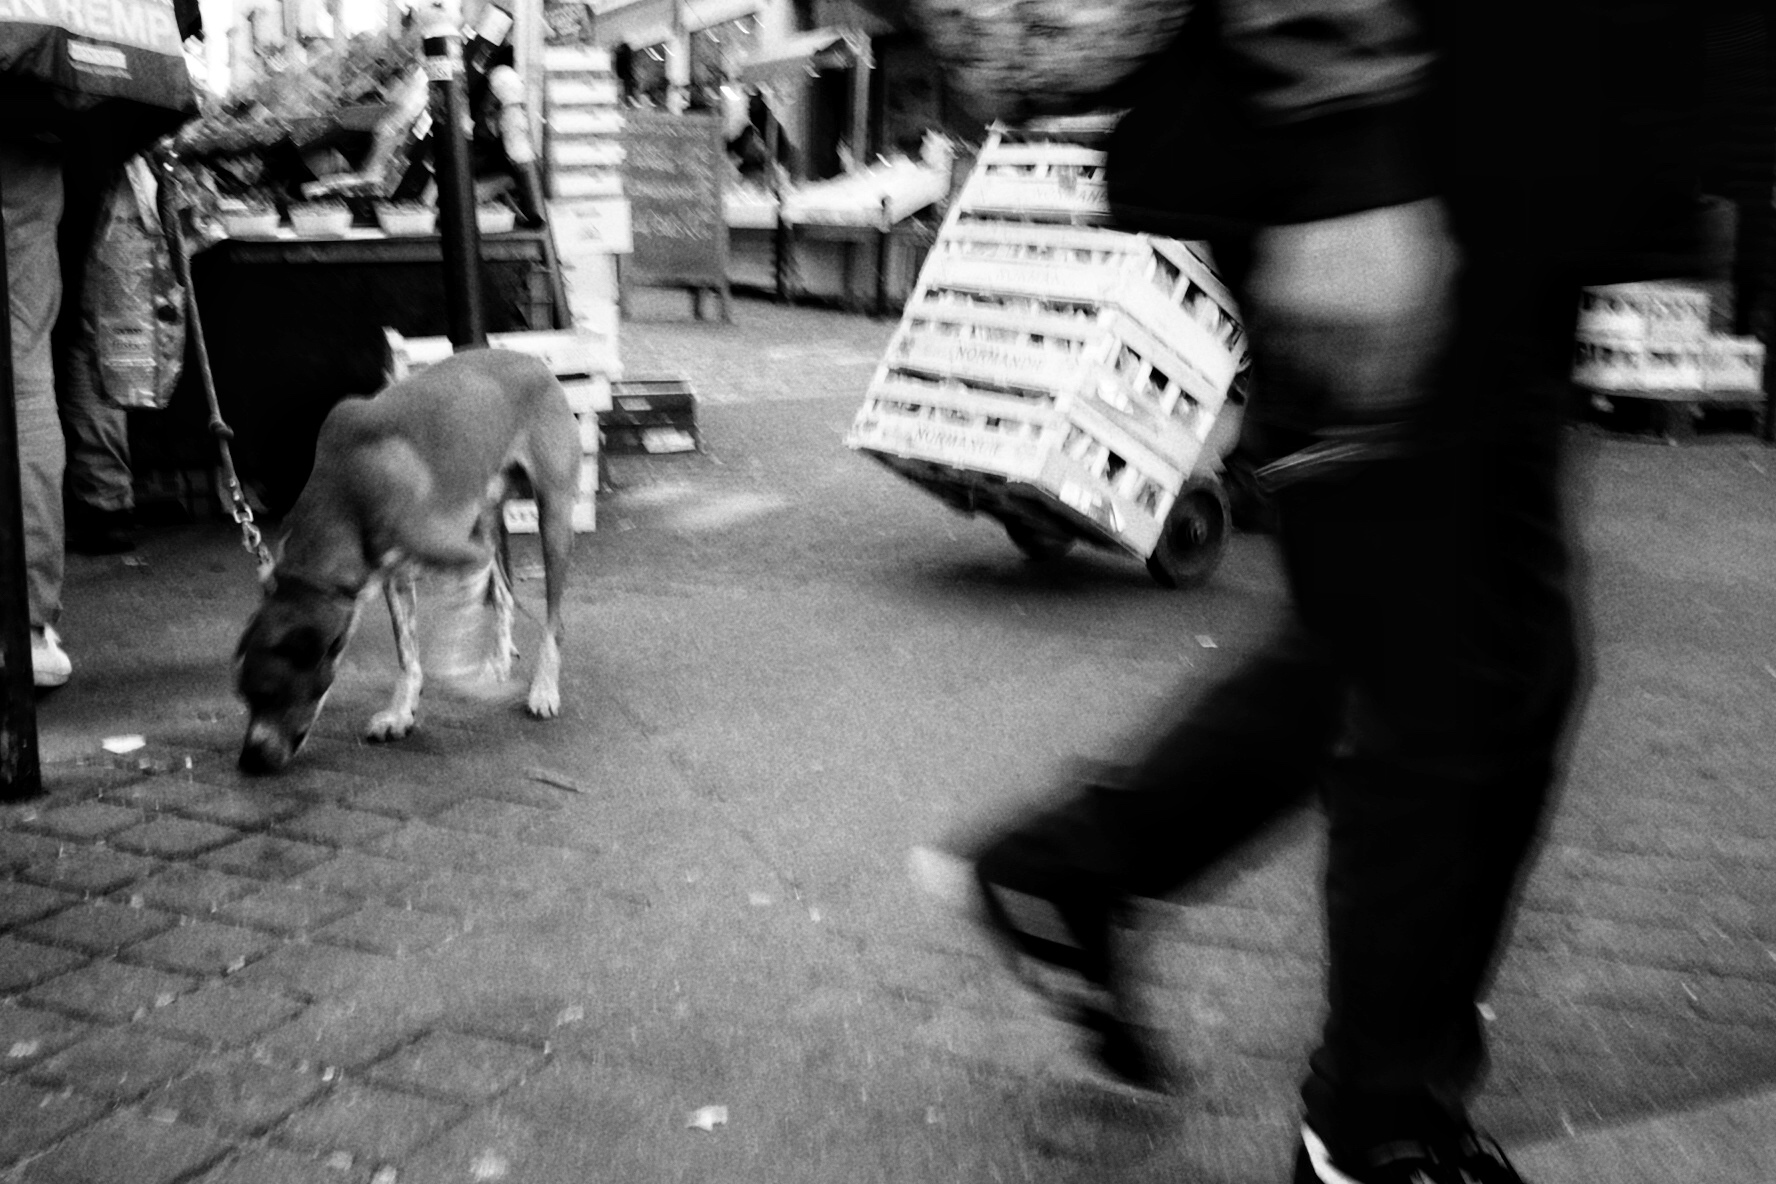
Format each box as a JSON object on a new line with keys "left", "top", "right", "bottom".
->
{"left": 83, "top": 156, "right": 185, "bottom": 410}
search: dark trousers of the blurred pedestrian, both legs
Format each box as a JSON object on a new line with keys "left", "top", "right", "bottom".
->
{"left": 998, "top": 252, "right": 1579, "bottom": 1147}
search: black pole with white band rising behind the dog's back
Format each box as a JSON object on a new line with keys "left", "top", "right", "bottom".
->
{"left": 424, "top": 14, "right": 487, "bottom": 350}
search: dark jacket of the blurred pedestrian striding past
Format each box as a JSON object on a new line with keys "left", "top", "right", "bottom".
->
{"left": 1108, "top": 0, "right": 1703, "bottom": 279}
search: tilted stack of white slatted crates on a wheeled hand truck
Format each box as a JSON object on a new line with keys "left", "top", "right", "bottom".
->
{"left": 845, "top": 128, "right": 1245, "bottom": 586}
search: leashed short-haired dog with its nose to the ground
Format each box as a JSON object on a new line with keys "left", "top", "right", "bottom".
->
{"left": 234, "top": 350, "right": 579, "bottom": 772}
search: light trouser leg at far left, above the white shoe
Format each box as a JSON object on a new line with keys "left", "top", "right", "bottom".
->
{"left": 0, "top": 142, "right": 66, "bottom": 627}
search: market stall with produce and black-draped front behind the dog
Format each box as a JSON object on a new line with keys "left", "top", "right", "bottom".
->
{"left": 142, "top": 4, "right": 603, "bottom": 509}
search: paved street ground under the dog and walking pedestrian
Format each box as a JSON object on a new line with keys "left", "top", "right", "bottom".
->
{"left": 0, "top": 296, "right": 1776, "bottom": 1184}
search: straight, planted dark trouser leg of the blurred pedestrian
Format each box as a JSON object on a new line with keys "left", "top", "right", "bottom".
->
{"left": 1282, "top": 264, "right": 1577, "bottom": 1148}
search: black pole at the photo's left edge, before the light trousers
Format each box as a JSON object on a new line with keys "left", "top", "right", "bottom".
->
{"left": 0, "top": 166, "right": 43, "bottom": 802}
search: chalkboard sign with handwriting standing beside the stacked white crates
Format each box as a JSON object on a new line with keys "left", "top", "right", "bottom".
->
{"left": 623, "top": 110, "right": 728, "bottom": 309}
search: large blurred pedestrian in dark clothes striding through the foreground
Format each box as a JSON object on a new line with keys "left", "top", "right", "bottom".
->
{"left": 902, "top": 0, "right": 1700, "bottom": 1184}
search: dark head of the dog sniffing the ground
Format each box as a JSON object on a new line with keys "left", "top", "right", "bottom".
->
{"left": 234, "top": 579, "right": 357, "bottom": 772}
